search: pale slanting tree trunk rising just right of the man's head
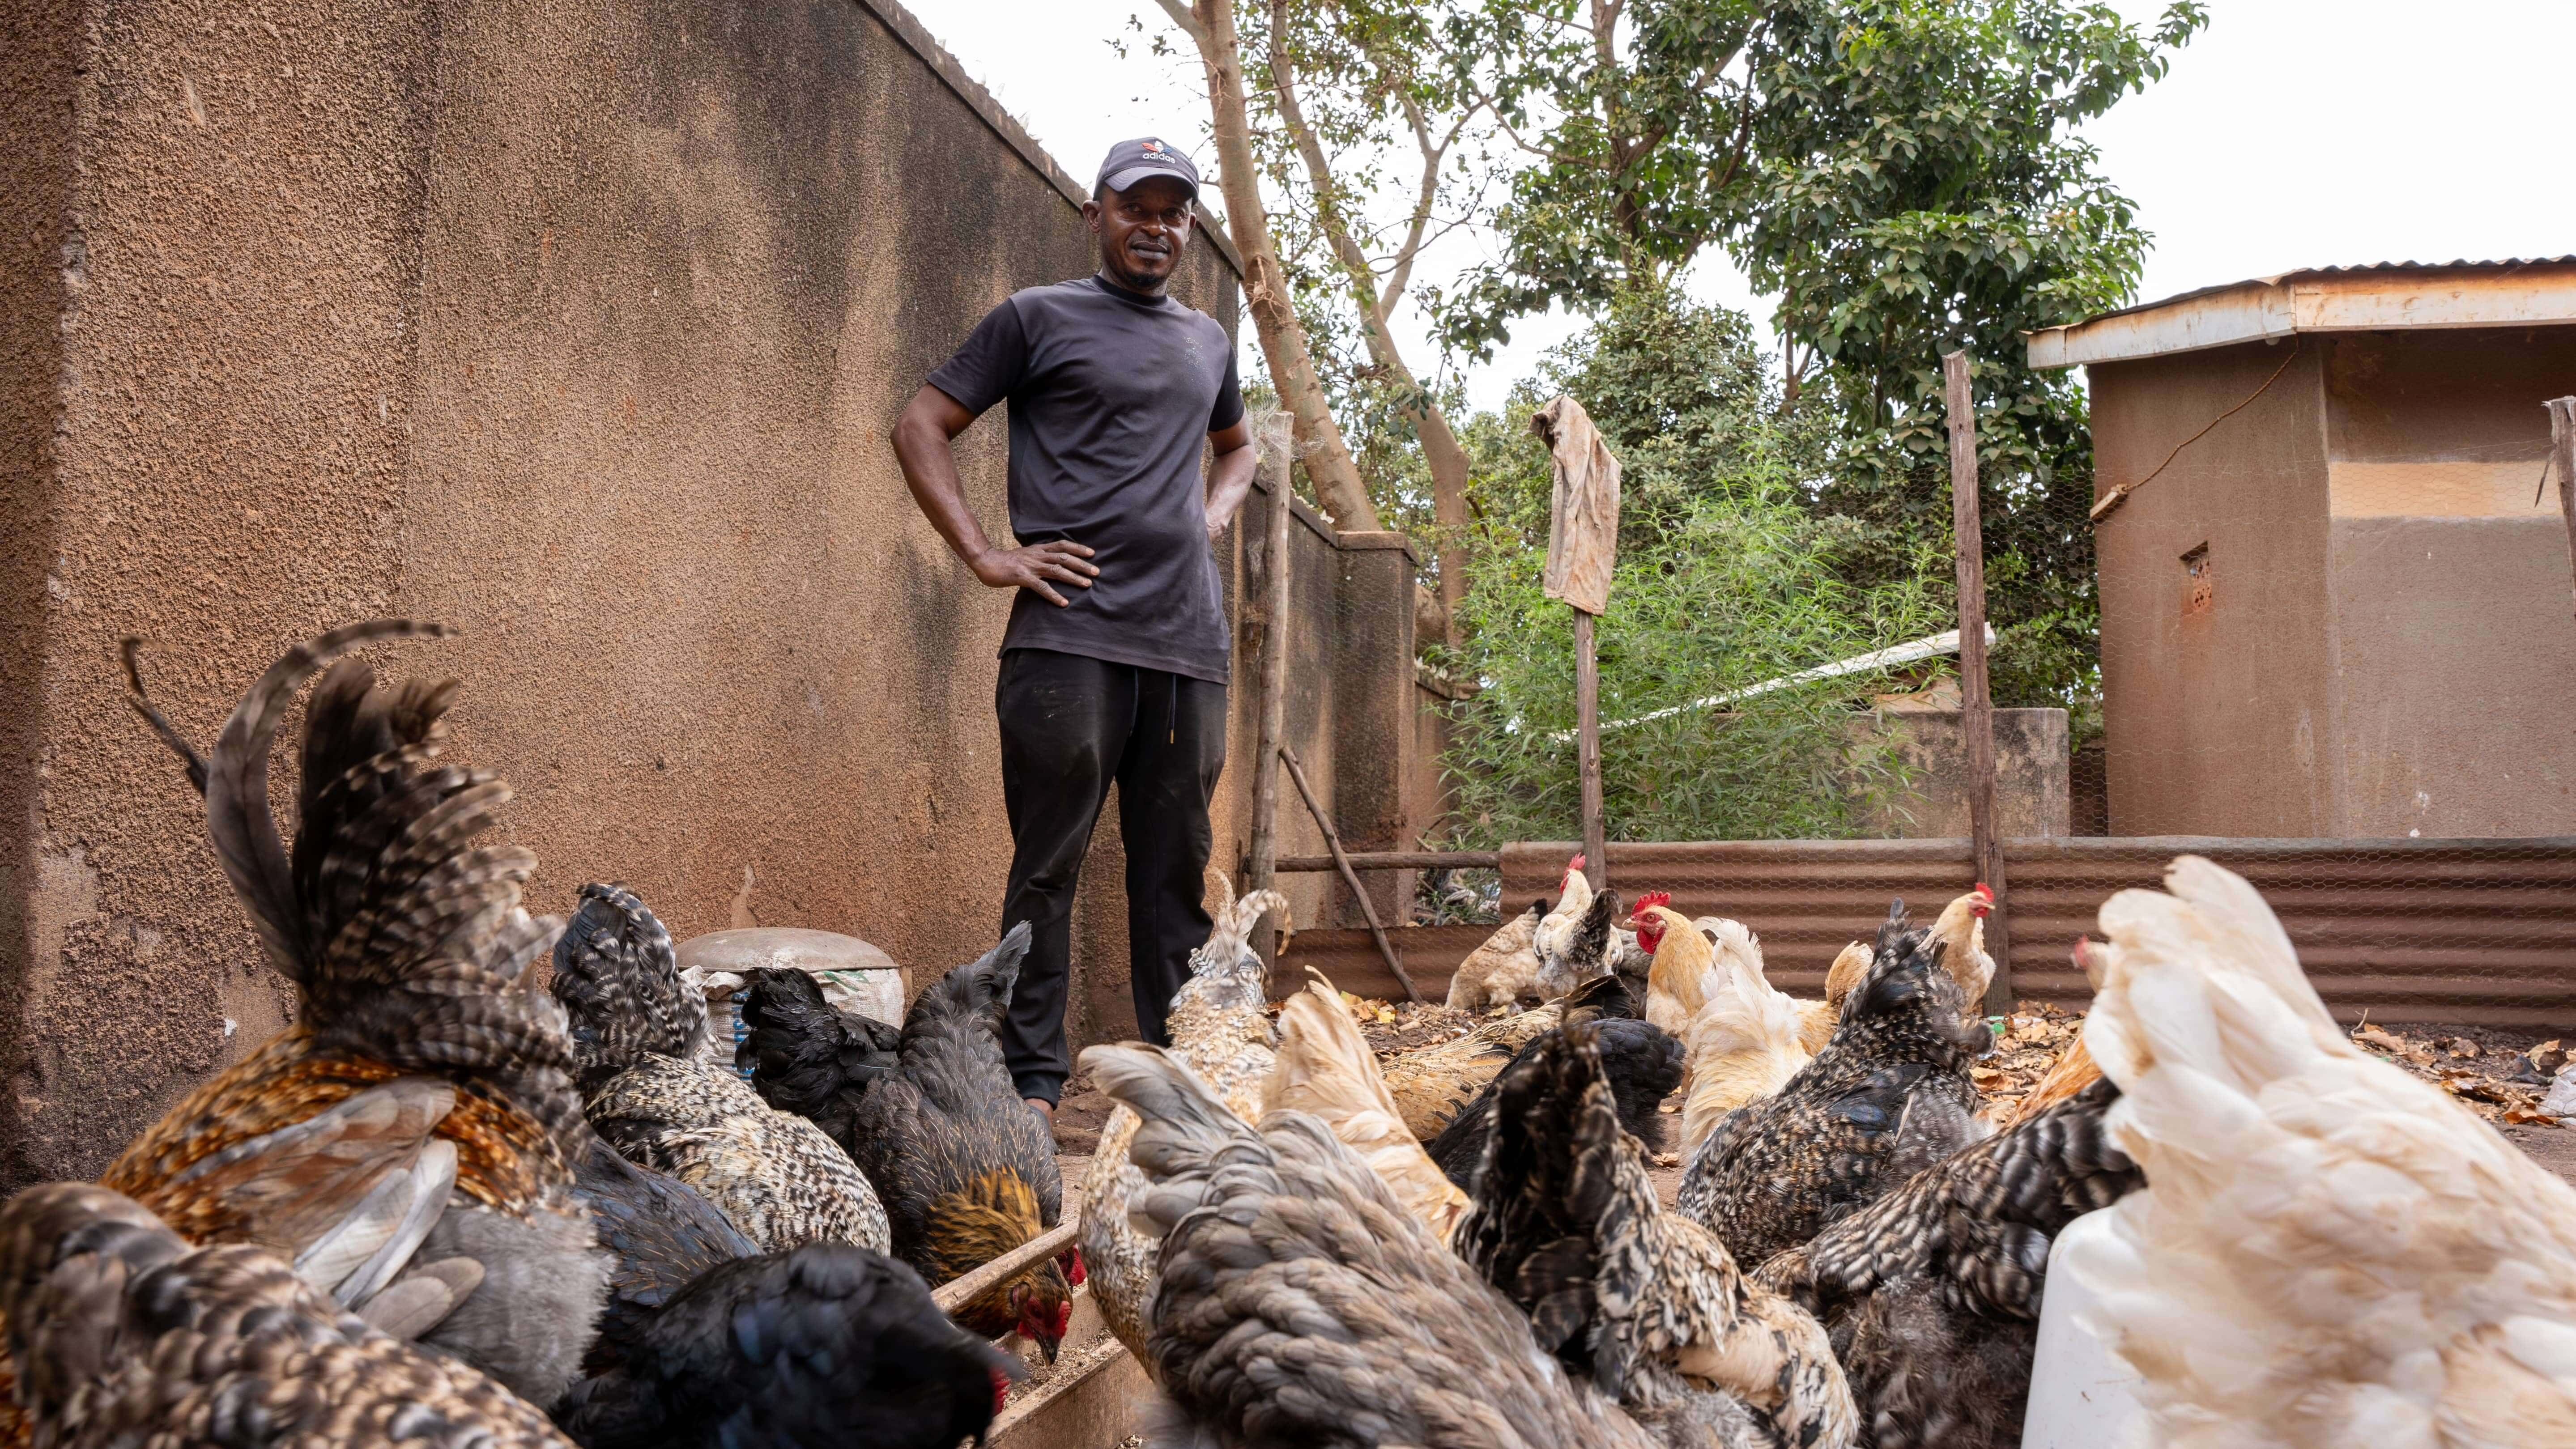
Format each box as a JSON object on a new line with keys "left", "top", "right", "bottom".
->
{"left": 1159, "top": 0, "right": 1378, "bottom": 533}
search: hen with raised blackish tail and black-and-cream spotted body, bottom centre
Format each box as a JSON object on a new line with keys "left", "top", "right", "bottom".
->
{"left": 1456, "top": 1022, "right": 1855, "bottom": 1449}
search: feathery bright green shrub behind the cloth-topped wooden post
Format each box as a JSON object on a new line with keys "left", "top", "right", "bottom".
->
{"left": 1448, "top": 291, "right": 1947, "bottom": 844}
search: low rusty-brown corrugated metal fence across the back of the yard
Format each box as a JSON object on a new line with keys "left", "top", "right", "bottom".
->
{"left": 1452, "top": 837, "right": 2576, "bottom": 1027}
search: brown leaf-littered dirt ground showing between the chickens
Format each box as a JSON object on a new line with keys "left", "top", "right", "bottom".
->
{"left": 1056, "top": 1001, "right": 2576, "bottom": 1204}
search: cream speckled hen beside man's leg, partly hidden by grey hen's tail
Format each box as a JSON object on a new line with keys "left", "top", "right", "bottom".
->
{"left": 1082, "top": 880, "right": 1288, "bottom": 1361}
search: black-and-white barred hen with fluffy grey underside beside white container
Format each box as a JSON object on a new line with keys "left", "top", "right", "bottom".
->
{"left": 1757, "top": 1081, "right": 2143, "bottom": 1449}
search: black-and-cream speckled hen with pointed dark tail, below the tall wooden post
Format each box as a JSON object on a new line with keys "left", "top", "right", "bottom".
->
{"left": 1680, "top": 903, "right": 1994, "bottom": 1264}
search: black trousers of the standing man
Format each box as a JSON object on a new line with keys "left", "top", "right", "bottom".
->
{"left": 992, "top": 649, "right": 1226, "bottom": 1101}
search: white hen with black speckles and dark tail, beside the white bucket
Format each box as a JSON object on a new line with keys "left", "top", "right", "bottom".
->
{"left": 554, "top": 885, "right": 889, "bottom": 1254}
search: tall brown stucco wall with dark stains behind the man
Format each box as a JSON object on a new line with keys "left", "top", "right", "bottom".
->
{"left": 0, "top": 0, "right": 1409, "bottom": 1184}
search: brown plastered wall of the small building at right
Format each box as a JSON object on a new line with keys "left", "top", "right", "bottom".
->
{"left": 2092, "top": 327, "right": 2576, "bottom": 837}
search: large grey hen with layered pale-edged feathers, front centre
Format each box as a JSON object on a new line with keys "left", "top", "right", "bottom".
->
{"left": 1082, "top": 1045, "right": 1659, "bottom": 1449}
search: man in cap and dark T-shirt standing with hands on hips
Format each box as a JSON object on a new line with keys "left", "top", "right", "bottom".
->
{"left": 894, "top": 139, "right": 1252, "bottom": 1117}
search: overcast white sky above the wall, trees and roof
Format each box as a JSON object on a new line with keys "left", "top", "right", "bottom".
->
{"left": 917, "top": 0, "right": 2576, "bottom": 407}
